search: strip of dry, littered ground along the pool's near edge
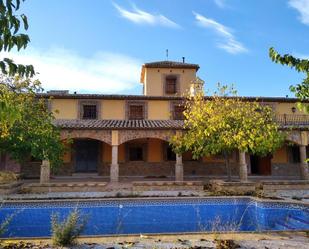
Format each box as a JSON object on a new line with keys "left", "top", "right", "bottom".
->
{"left": 2, "top": 232, "right": 309, "bottom": 249}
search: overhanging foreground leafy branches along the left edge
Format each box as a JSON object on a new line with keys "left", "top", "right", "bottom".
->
{"left": 0, "top": 0, "right": 35, "bottom": 137}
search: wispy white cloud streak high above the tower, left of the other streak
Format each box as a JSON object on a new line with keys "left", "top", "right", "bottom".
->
{"left": 114, "top": 3, "right": 180, "bottom": 28}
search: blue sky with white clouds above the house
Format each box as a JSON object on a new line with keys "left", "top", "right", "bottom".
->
{"left": 2, "top": 0, "right": 309, "bottom": 97}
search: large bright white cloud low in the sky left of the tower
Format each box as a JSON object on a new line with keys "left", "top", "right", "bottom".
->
{"left": 1, "top": 48, "right": 142, "bottom": 93}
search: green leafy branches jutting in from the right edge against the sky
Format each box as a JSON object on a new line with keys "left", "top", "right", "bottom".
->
{"left": 269, "top": 48, "right": 309, "bottom": 113}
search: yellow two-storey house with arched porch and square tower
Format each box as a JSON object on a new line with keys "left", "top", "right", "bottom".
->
{"left": 0, "top": 61, "right": 309, "bottom": 182}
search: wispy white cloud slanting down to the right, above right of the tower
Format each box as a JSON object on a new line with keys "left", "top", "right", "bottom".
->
{"left": 193, "top": 12, "right": 248, "bottom": 54}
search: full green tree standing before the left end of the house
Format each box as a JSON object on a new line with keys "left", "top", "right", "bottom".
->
{"left": 0, "top": 76, "right": 64, "bottom": 166}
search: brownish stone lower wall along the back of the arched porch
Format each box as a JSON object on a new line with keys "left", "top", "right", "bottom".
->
{"left": 21, "top": 161, "right": 300, "bottom": 178}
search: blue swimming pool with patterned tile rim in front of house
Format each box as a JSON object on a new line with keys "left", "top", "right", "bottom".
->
{"left": 0, "top": 197, "right": 309, "bottom": 237}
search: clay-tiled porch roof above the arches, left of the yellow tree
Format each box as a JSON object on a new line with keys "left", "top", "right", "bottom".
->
{"left": 54, "top": 119, "right": 184, "bottom": 130}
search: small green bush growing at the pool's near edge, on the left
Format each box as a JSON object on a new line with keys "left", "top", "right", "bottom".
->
{"left": 51, "top": 209, "right": 87, "bottom": 246}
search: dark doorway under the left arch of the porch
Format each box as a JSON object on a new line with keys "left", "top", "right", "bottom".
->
{"left": 74, "top": 140, "right": 99, "bottom": 173}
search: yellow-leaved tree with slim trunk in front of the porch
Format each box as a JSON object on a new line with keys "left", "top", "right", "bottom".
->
{"left": 171, "top": 85, "right": 284, "bottom": 180}
